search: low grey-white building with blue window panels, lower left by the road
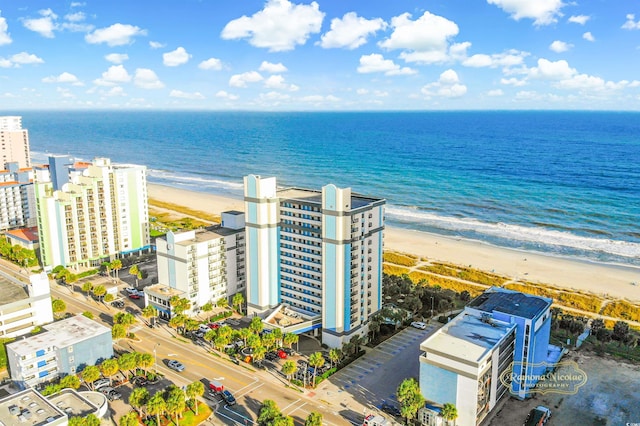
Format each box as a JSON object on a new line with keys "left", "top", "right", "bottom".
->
{"left": 6, "top": 315, "right": 113, "bottom": 388}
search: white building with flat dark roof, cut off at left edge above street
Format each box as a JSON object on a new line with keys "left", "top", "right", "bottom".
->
{"left": 0, "top": 272, "right": 53, "bottom": 338}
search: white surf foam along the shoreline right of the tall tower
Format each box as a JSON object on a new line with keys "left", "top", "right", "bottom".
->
{"left": 386, "top": 206, "right": 640, "bottom": 258}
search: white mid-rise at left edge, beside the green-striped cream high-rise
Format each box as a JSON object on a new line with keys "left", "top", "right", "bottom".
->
{"left": 0, "top": 161, "right": 36, "bottom": 231}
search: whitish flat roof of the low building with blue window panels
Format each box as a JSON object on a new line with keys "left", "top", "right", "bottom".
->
{"left": 7, "top": 315, "right": 111, "bottom": 355}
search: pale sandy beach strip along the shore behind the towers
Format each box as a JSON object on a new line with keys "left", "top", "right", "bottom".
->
{"left": 148, "top": 184, "right": 640, "bottom": 302}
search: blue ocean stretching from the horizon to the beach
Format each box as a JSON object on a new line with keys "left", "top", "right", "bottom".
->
{"left": 10, "top": 111, "right": 640, "bottom": 266}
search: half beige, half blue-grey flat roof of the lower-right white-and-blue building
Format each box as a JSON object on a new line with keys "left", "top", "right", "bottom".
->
{"left": 420, "top": 310, "right": 515, "bottom": 362}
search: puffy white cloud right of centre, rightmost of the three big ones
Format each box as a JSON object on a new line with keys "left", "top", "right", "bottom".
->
{"left": 378, "top": 12, "right": 459, "bottom": 52}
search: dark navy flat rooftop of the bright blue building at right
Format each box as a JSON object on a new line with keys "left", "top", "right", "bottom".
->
{"left": 468, "top": 287, "right": 553, "bottom": 319}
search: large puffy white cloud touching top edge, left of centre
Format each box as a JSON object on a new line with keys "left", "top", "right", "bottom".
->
{"left": 221, "top": 0, "right": 324, "bottom": 52}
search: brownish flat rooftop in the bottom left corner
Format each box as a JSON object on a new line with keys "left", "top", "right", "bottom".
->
{"left": 0, "top": 389, "right": 65, "bottom": 426}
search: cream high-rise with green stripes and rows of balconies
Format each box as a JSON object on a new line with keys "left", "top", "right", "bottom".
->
{"left": 34, "top": 157, "right": 150, "bottom": 270}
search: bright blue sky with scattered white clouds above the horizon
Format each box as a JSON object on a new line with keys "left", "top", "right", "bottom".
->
{"left": 0, "top": 0, "right": 640, "bottom": 111}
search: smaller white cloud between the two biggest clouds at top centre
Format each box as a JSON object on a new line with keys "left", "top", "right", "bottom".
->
{"left": 317, "top": 12, "right": 387, "bottom": 49}
